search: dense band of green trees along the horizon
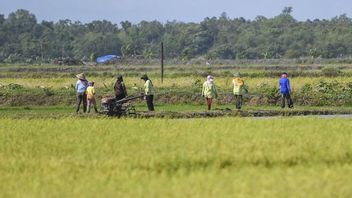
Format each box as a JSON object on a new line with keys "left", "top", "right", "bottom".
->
{"left": 0, "top": 7, "right": 352, "bottom": 63}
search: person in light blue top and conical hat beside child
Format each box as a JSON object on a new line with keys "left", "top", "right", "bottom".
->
{"left": 76, "top": 73, "right": 88, "bottom": 113}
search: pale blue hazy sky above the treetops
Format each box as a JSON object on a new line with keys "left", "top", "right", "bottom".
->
{"left": 0, "top": 0, "right": 352, "bottom": 23}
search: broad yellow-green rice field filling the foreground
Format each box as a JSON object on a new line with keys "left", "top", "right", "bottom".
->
{"left": 0, "top": 117, "right": 352, "bottom": 197}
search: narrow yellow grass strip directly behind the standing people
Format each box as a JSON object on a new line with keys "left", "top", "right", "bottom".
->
{"left": 0, "top": 77, "right": 352, "bottom": 90}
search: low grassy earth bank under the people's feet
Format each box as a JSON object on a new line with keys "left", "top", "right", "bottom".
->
{"left": 0, "top": 108, "right": 352, "bottom": 119}
